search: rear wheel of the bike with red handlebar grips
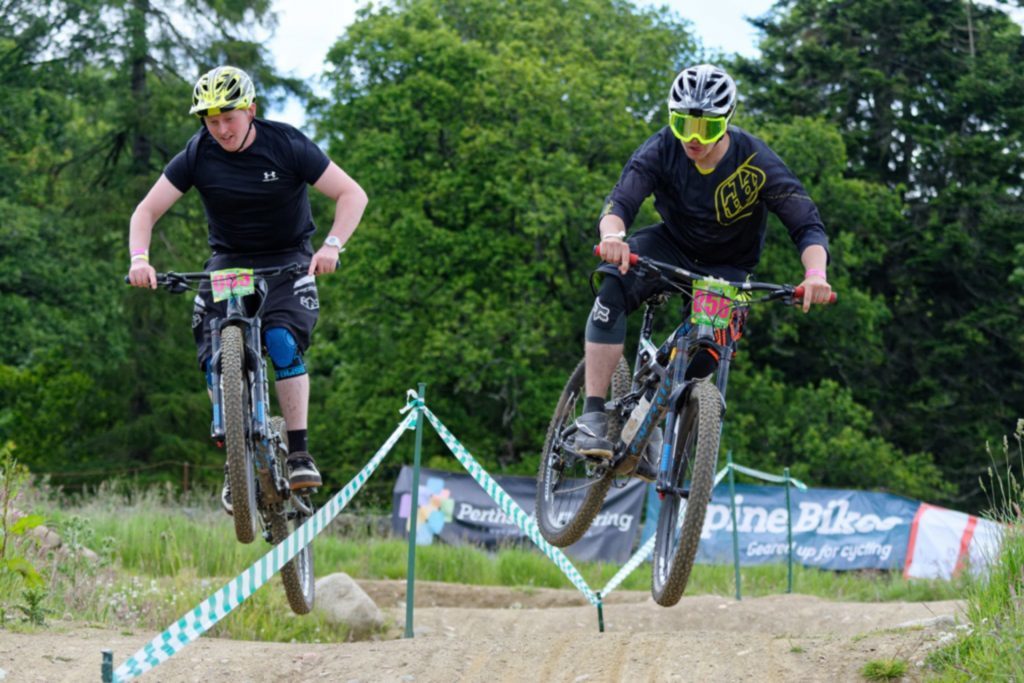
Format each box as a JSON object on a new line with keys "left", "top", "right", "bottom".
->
{"left": 536, "top": 358, "right": 631, "bottom": 548}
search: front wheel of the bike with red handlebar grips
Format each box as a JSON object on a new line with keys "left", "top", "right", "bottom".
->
{"left": 650, "top": 382, "right": 722, "bottom": 607}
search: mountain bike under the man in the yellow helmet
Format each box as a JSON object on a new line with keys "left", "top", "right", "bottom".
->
{"left": 125, "top": 263, "right": 314, "bottom": 614}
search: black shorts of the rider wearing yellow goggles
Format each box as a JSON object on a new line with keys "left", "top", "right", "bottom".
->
{"left": 597, "top": 223, "right": 751, "bottom": 314}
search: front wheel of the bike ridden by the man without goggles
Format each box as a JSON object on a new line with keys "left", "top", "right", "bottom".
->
{"left": 220, "top": 326, "right": 256, "bottom": 543}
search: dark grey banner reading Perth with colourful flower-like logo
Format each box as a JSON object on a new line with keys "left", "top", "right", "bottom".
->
{"left": 391, "top": 465, "right": 645, "bottom": 563}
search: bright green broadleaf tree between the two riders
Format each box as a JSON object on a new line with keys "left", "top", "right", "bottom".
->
{"left": 313, "top": 0, "right": 693, "bottom": 501}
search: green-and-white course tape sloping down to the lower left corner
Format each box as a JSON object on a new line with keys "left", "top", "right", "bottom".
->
{"left": 114, "top": 411, "right": 417, "bottom": 682}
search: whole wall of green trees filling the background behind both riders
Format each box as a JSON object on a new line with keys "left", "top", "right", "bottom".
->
{"left": 0, "top": 0, "right": 1024, "bottom": 510}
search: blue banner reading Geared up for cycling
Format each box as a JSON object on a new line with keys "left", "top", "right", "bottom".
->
{"left": 697, "top": 484, "right": 920, "bottom": 570}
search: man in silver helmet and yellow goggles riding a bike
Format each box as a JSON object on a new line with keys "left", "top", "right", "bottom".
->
{"left": 575, "top": 65, "right": 831, "bottom": 480}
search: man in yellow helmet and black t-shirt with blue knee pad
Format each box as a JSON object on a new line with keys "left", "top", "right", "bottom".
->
{"left": 128, "top": 66, "right": 367, "bottom": 514}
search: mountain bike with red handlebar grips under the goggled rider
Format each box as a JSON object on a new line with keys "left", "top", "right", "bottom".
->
{"left": 536, "top": 254, "right": 836, "bottom": 606}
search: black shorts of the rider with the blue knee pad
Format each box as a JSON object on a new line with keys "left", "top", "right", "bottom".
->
{"left": 191, "top": 249, "right": 319, "bottom": 372}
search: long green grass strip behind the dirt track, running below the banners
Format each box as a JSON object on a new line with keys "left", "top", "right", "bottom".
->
{"left": 0, "top": 479, "right": 959, "bottom": 651}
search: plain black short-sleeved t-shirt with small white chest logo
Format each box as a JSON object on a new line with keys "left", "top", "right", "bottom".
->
{"left": 164, "top": 119, "right": 330, "bottom": 254}
